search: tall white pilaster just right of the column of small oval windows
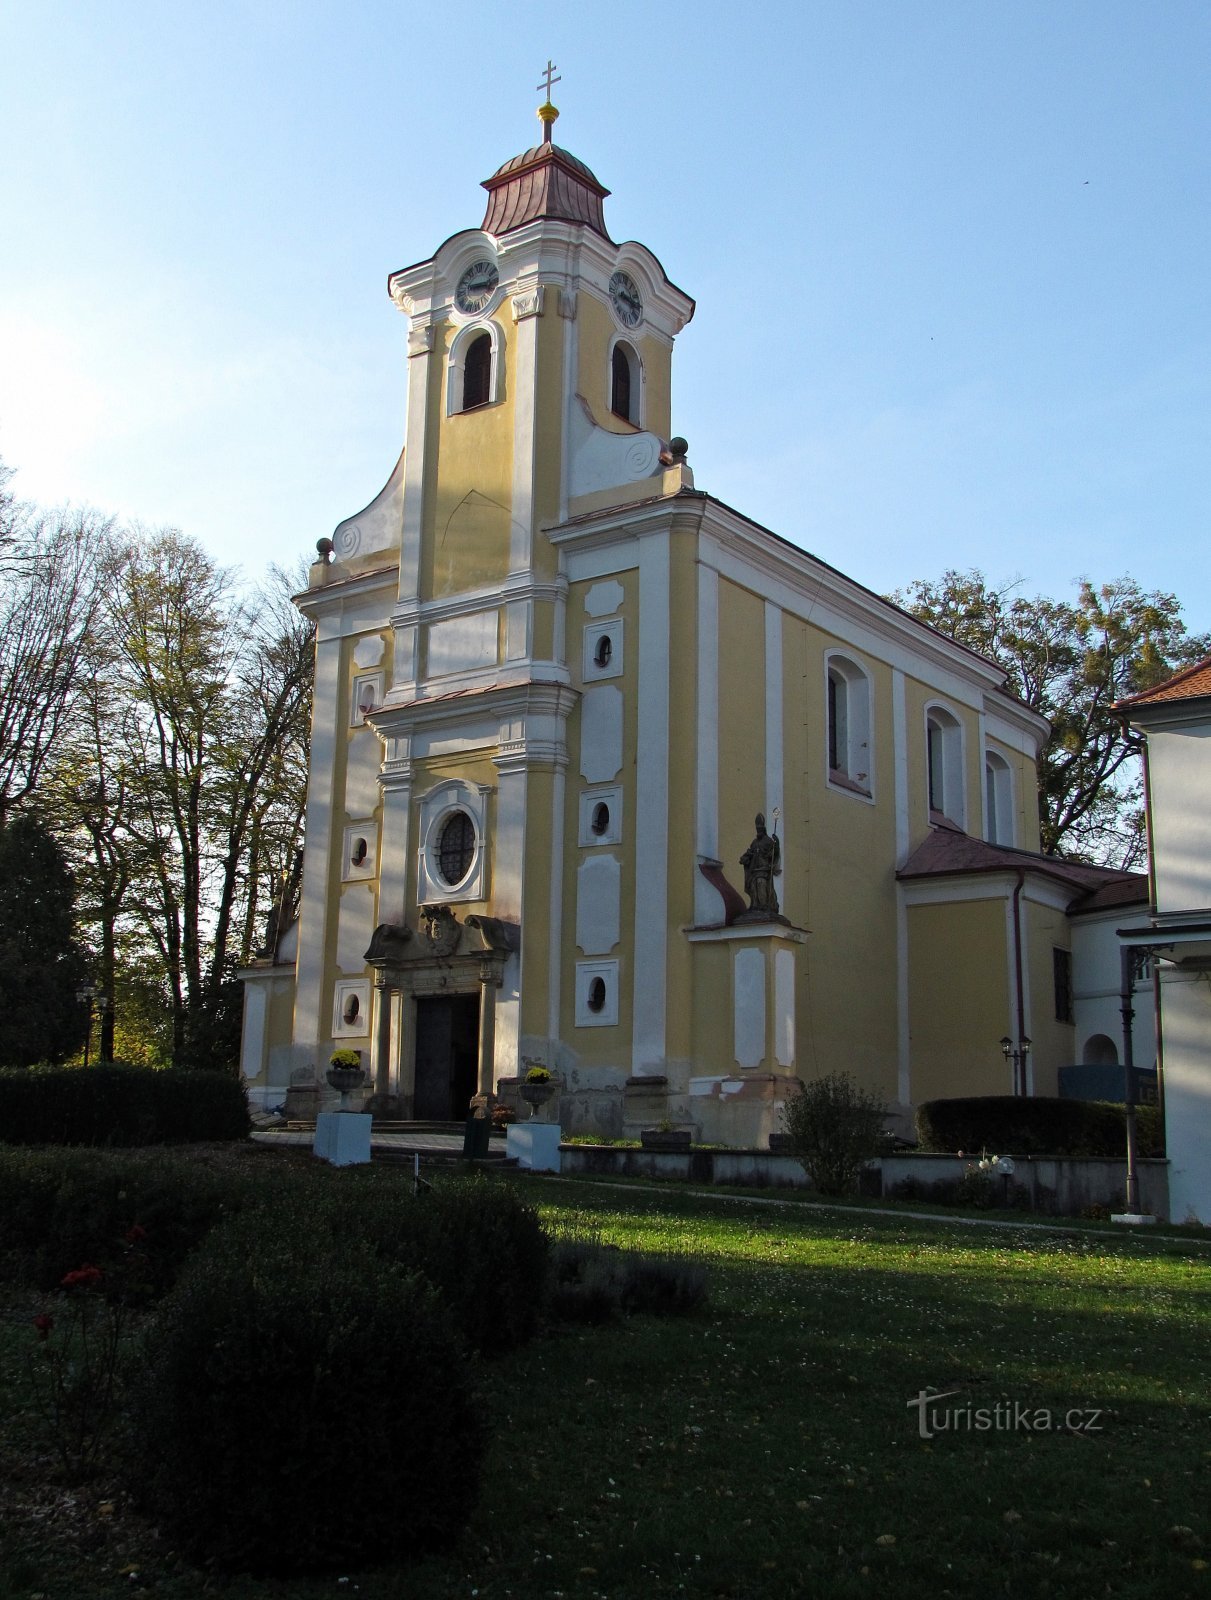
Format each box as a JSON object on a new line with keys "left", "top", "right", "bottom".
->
{"left": 633, "top": 530, "right": 670, "bottom": 1077}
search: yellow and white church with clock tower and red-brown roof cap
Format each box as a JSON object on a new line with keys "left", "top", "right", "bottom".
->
{"left": 242, "top": 112, "right": 1132, "bottom": 1146}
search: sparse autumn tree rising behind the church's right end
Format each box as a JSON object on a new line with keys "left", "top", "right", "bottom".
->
{"left": 891, "top": 570, "right": 1211, "bottom": 869}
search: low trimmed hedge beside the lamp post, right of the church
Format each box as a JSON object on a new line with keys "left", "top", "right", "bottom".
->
{"left": 917, "top": 1094, "right": 1165, "bottom": 1157}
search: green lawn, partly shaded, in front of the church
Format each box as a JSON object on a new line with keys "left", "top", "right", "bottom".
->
{"left": 0, "top": 1178, "right": 1211, "bottom": 1600}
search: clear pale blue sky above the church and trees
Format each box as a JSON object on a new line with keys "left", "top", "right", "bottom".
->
{"left": 0, "top": 0, "right": 1211, "bottom": 629}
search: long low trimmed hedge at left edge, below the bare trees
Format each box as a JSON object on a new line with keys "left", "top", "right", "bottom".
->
{"left": 0, "top": 1062, "right": 250, "bottom": 1146}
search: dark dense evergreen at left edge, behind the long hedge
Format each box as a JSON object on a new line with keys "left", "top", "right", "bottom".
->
{"left": 0, "top": 811, "right": 91, "bottom": 1067}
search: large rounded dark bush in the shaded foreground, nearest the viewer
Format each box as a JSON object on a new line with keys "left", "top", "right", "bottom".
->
{"left": 128, "top": 1214, "right": 483, "bottom": 1576}
